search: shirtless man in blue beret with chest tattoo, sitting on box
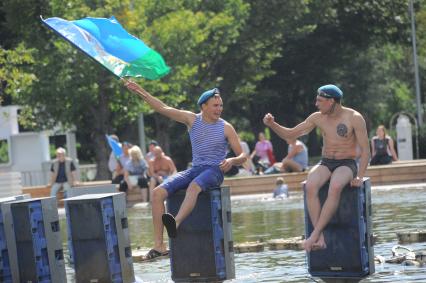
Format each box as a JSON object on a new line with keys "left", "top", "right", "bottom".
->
{"left": 263, "top": 85, "right": 370, "bottom": 252}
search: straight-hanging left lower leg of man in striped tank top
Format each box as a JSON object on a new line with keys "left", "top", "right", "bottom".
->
{"left": 152, "top": 187, "right": 168, "bottom": 252}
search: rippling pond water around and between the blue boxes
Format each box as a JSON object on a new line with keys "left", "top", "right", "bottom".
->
{"left": 63, "top": 186, "right": 426, "bottom": 283}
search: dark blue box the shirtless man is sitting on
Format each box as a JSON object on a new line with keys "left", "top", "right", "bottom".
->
{"left": 305, "top": 178, "right": 374, "bottom": 278}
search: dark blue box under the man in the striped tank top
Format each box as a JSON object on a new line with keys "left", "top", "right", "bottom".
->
{"left": 167, "top": 187, "right": 235, "bottom": 282}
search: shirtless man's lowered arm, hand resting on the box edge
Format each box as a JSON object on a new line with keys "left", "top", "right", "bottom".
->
{"left": 352, "top": 113, "right": 370, "bottom": 187}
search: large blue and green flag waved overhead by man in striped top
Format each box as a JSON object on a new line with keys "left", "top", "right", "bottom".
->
{"left": 41, "top": 16, "right": 170, "bottom": 80}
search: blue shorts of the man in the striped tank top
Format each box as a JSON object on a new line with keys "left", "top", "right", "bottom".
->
{"left": 161, "top": 165, "right": 223, "bottom": 195}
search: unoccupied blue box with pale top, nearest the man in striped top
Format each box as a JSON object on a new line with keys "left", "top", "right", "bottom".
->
{"left": 65, "top": 193, "right": 135, "bottom": 283}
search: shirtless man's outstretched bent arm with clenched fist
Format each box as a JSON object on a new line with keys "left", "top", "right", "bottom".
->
{"left": 263, "top": 113, "right": 319, "bottom": 142}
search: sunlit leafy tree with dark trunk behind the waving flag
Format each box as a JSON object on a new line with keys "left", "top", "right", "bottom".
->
{"left": 3, "top": 0, "right": 251, "bottom": 179}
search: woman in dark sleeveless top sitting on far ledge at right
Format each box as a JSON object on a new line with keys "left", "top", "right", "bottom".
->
{"left": 370, "top": 125, "right": 398, "bottom": 165}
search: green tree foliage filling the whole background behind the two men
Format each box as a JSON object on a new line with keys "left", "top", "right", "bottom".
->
{"left": 0, "top": 0, "right": 426, "bottom": 171}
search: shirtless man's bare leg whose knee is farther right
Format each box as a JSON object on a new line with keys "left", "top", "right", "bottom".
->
{"left": 304, "top": 166, "right": 353, "bottom": 252}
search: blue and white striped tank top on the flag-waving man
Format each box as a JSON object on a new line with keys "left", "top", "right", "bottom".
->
{"left": 189, "top": 113, "right": 228, "bottom": 166}
